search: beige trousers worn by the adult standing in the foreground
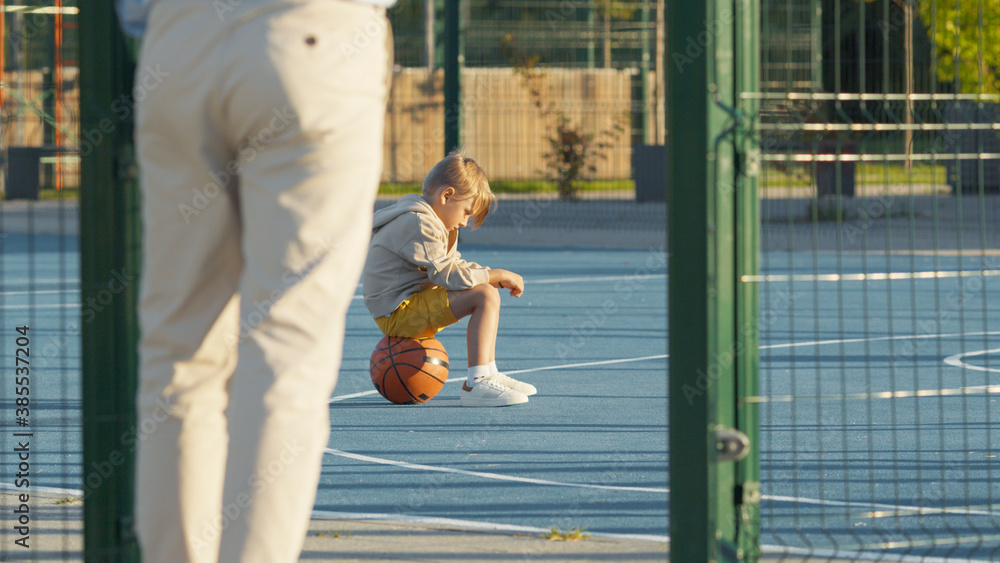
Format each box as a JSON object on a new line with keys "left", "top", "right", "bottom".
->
{"left": 127, "top": 0, "right": 391, "bottom": 563}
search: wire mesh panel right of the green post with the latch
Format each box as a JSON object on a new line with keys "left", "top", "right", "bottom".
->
{"left": 741, "top": 0, "right": 1000, "bottom": 561}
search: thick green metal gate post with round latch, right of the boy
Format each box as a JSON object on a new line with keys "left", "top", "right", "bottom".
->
{"left": 666, "top": 0, "right": 738, "bottom": 563}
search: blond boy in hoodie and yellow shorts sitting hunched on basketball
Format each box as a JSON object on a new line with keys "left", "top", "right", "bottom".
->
{"left": 362, "top": 152, "right": 535, "bottom": 407}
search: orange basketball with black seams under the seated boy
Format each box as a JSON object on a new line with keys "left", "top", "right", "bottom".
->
{"left": 369, "top": 336, "right": 448, "bottom": 405}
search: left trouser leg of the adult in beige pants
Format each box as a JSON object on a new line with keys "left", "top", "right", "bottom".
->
{"left": 134, "top": 2, "right": 243, "bottom": 563}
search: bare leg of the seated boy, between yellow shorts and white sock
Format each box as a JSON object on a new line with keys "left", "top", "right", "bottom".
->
{"left": 448, "top": 284, "right": 500, "bottom": 368}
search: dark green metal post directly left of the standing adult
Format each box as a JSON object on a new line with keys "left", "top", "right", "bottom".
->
{"left": 80, "top": 0, "right": 139, "bottom": 562}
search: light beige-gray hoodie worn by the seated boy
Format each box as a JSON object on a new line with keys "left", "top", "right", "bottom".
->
{"left": 362, "top": 194, "right": 490, "bottom": 318}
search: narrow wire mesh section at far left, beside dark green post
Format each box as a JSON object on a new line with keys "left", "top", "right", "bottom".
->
{"left": 0, "top": 0, "right": 82, "bottom": 560}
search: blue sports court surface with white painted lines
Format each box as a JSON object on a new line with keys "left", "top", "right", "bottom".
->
{"left": 0, "top": 231, "right": 1000, "bottom": 561}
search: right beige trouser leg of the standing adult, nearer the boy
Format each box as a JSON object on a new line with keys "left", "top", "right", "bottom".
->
{"left": 220, "top": 0, "right": 390, "bottom": 563}
